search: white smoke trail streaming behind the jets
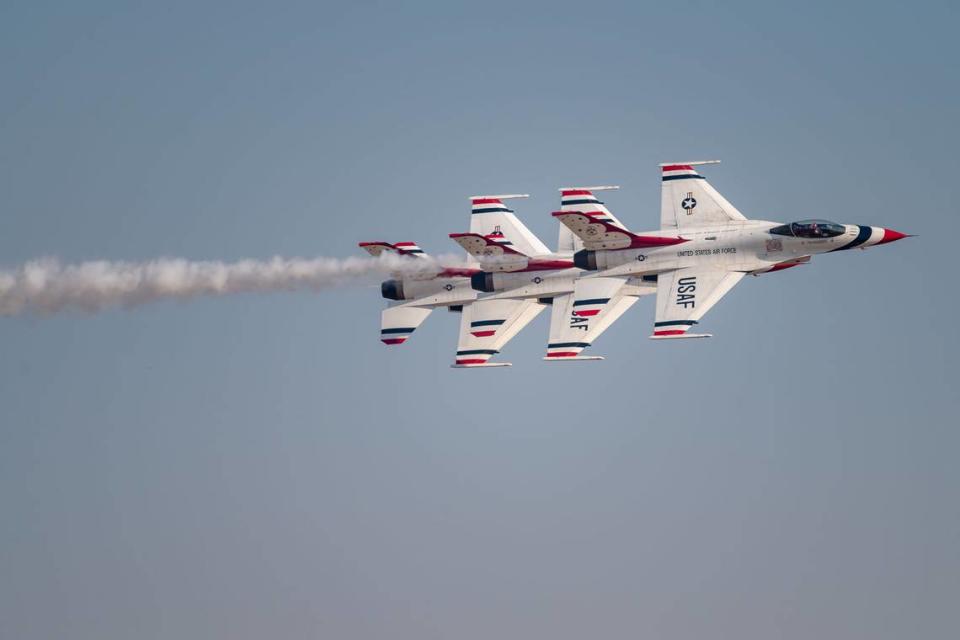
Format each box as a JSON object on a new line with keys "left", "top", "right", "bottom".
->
{"left": 0, "top": 254, "right": 458, "bottom": 316}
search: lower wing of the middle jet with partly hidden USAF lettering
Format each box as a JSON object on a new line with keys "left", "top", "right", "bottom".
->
{"left": 544, "top": 277, "right": 656, "bottom": 362}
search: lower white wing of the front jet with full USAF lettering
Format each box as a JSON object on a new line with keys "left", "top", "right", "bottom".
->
{"left": 650, "top": 267, "right": 746, "bottom": 338}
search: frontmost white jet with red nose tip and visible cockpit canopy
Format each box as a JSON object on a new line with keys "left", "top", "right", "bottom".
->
{"left": 552, "top": 160, "right": 907, "bottom": 339}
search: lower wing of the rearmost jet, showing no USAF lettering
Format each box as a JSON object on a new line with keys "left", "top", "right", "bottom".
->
{"left": 453, "top": 299, "right": 546, "bottom": 367}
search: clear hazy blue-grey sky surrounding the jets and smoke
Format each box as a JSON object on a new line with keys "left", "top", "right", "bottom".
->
{"left": 0, "top": 0, "right": 960, "bottom": 640}
